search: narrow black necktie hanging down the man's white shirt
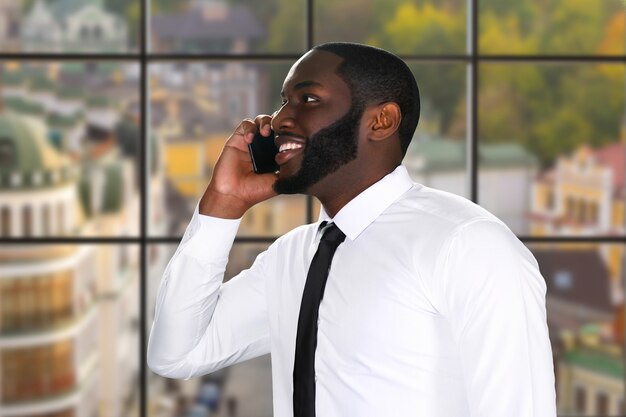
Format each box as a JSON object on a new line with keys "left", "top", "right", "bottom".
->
{"left": 293, "top": 223, "right": 346, "bottom": 417}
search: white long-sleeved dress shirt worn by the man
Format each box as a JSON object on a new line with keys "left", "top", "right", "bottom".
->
{"left": 148, "top": 166, "right": 556, "bottom": 417}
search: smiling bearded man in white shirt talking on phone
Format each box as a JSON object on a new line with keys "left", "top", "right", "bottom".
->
{"left": 148, "top": 43, "right": 556, "bottom": 417}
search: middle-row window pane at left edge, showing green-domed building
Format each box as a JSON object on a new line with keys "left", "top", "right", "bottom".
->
{"left": 0, "top": 62, "right": 140, "bottom": 237}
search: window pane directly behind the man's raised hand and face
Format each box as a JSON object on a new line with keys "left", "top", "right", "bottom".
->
{"left": 149, "top": 62, "right": 306, "bottom": 236}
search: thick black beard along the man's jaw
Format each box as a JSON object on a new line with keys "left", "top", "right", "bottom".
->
{"left": 274, "top": 106, "right": 363, "bottom": 194}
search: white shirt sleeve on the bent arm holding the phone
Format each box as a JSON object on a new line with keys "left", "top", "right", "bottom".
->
{"left": 148, "top": 207, "right": 269, "bottom": 379}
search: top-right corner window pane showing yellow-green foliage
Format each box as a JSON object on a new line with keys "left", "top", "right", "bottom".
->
{"left": 478, "top": 0, "right": 625, "bottom": 55}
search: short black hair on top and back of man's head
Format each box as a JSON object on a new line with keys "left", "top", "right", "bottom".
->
{"left": 313, "top": 42, "right": 420, "bottom": 156}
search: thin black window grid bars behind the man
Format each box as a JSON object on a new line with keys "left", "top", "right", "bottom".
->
{"left": 0, "top": 0, "right": 626, "bottom": 417}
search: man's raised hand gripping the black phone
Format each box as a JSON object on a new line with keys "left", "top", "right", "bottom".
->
{"left": 199, "top": 115, "right": 277, "bottom": 219}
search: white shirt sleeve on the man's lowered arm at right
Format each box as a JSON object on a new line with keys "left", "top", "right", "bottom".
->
{"left": 440, "top": 220, "right": 556, "bottom": 417}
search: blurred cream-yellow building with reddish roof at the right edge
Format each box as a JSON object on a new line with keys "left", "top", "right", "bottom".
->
{"left": 531, "top": 143, "right": 626, "bottom": 303}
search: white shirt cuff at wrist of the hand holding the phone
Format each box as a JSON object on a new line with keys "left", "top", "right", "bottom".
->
{"left": 182, "top": 207, "right": 241, "bottom": 261}
